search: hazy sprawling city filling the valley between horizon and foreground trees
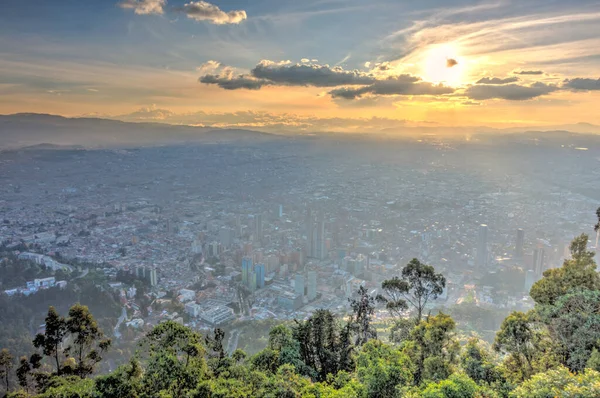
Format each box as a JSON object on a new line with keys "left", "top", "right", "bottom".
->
{"left": 0, "top": 129, "right": 600, "bottom": 396}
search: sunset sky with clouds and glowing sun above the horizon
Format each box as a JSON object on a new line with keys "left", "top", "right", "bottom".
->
{"left": 0, "top": 0, "right": 600, "bottom": 131}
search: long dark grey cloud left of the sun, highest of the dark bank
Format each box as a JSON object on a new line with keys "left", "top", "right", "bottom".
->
{"left": 250, "top": 61, "right": 375, "bottom": 87}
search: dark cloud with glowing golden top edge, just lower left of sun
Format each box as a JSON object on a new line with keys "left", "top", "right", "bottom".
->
{"left": 329, "top": 75, "right": 455, "bottom": 99}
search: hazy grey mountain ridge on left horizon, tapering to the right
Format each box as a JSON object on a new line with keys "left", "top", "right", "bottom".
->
{"left": 0, "top": 113, "right": 278, "bottom": 149}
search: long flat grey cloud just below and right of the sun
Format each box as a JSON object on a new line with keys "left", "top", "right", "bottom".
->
{"left": 464, "top": 83, "right": 559, "bottom": 101}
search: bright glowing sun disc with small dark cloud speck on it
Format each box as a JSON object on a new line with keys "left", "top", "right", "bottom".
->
{"left": 422, "top": 44, "right": 466, "bottom": 86}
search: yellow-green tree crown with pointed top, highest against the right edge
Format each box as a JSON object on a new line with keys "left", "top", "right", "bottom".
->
{"left": 529, "top": 234, "right": 600, "bottom": 305}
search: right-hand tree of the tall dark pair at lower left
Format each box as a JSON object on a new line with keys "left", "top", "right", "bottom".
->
{"left": 65, "top": 304, "right": 111, "bottom": 379}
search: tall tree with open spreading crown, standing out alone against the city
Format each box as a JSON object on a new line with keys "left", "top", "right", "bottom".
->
{"left": 377, "top": 258, "right": 446, "bottom": 322}
